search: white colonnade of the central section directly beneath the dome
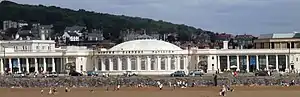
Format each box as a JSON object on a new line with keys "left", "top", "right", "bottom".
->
{"left": 93, "top": 56, "right": 188, "bottom": 71}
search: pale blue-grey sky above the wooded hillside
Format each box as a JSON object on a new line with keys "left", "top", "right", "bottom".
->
{"left": 7, "top": 0, "right": 300, "bottom": 35}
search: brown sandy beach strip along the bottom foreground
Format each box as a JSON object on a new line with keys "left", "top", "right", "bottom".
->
{"left": 0, "top": 86, "right": 300, "bottom": 97}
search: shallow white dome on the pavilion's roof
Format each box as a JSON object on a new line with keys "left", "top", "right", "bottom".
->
{"left": 109, "top": 39, "right": 182, "bottom": 51}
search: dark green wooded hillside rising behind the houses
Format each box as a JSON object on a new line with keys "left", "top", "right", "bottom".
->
{"left": 0, "top": 1, "right": 214, "bottom": 41}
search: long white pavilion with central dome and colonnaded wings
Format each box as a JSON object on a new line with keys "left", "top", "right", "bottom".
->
{"left": 0, "top": 39, "right": 300, "bottom": 75}
